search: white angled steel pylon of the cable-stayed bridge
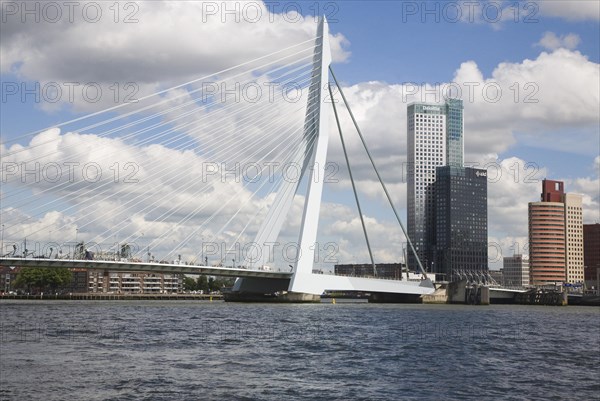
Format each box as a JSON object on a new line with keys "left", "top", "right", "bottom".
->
{"left": 233, "top": 17, "right": 434, "bottom": 295}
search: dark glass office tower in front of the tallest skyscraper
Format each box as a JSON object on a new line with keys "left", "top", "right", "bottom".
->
{"left": 428, "top": 166, "right": 488, "bottom": 281}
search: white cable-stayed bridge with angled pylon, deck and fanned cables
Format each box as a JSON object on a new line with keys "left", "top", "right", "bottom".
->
{"left": 0, "top": 18, "right": 435, "bottom": 301}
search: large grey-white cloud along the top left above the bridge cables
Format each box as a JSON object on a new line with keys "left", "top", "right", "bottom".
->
{"left": 0, "top": 1, "right": 349, "bottom": 110}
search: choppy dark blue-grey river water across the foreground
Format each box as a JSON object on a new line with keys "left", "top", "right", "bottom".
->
{"left": 0, "top": 301, "right": 600, "bottom": 401}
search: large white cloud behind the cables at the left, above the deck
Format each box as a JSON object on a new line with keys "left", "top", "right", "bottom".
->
{"left": 1, "top": 129, "right": 272, "bottom": 256}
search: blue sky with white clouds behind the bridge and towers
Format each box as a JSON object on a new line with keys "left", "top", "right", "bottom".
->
{"left": 0, "top": 0, "right": 600, "bottom": 269}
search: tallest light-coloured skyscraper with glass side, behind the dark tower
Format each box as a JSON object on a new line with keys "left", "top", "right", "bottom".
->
{"left": 407, "top": 99, "right": 463, "bottom": 269}
